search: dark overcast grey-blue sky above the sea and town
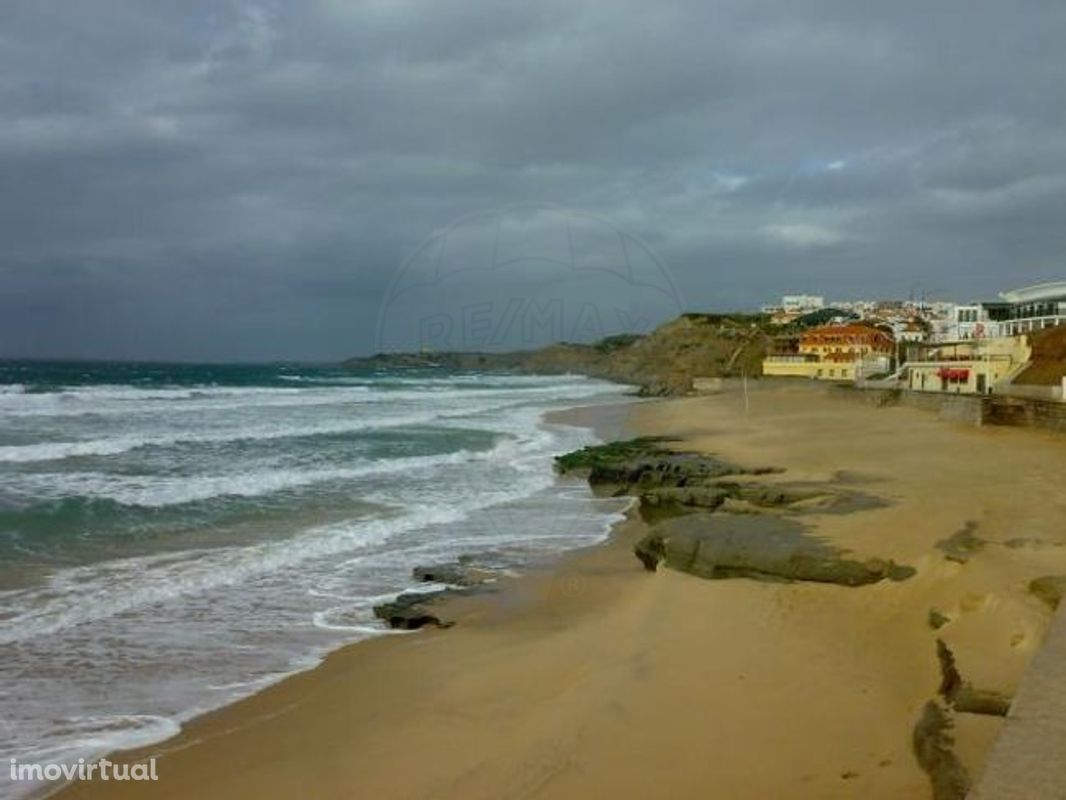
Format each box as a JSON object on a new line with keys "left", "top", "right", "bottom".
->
{"left": 0, "top": 0, "right": 1066, "bottom": 361}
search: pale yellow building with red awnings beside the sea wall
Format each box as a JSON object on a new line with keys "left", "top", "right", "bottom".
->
{"left": 904, "top": 336, "right": 1032, "bottom": 395}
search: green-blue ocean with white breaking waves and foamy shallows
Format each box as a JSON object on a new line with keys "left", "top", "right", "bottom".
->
{"left": 0, "top": 362, "right": 624, "bottom": 796}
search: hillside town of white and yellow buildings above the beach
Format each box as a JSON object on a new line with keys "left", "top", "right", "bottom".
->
{"left": 762, "top": 282, "right": 1066, "bottom": 401}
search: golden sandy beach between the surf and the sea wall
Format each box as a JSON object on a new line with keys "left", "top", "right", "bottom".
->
{"left": 54, "top": 384, "right": 1066, "bottom": 800}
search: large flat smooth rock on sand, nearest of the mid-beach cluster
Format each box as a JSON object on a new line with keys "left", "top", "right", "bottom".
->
{"left": 634, "top": 514, "right": 915, "bottom": 587}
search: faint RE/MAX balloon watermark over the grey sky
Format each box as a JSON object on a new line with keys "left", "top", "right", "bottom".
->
{"left": 376, "top": 205, "right": 682, "bottom": 353}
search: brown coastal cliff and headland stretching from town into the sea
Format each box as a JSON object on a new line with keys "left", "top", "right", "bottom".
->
{"left": 343, "top": 314, "right": 769, "bottom": 395}
